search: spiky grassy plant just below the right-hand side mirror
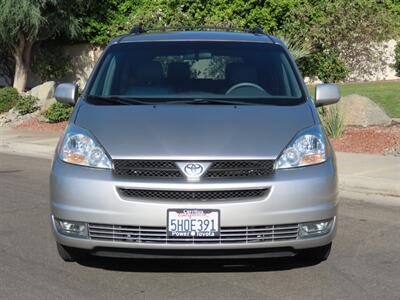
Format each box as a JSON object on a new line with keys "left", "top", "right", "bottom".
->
{"left": 319, "top": 104, "right": 345, "bottom": 138}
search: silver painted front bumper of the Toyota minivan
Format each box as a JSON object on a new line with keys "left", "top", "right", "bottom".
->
{"left": 50, "top": 157, "right": 338, "bottom": 256}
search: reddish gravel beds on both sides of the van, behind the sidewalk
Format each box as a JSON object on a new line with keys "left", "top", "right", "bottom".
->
{"left": 10, "top": 119, "right": 400, "bottom": 155}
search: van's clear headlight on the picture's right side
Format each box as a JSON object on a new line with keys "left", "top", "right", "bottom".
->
{"left": 276, "top": 125, "right": 330, "bottom": 169}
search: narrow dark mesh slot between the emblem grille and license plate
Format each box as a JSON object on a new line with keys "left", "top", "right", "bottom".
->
{"left": 118, "top": 188, "right": 268, "bottom": 201}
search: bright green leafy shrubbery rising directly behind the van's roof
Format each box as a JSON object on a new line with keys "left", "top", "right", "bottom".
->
{"left": 83, "top": 0, "right": 301, "bottom": 44}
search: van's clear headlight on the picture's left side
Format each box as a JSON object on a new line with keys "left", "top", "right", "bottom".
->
{"left": 58, "top": 124, "right": 111, "bottom": 169}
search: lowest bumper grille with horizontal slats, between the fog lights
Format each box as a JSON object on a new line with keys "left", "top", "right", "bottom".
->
{"left": 88, "top": 223, "right": 299, "bottom": 244}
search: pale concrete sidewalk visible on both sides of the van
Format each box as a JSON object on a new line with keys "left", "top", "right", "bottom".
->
{"left": 0, "top": 128, "right": 400, "bottom": 205}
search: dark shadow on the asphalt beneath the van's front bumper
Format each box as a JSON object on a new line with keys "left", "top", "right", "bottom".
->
{"left": 78, "top": 256, "right": 320, "bottom": 273}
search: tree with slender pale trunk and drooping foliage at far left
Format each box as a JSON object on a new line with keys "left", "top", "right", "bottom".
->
{"left": 0, "top": 0, "right": 86, "bottom": 92}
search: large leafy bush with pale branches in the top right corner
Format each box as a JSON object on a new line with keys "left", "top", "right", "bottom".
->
{"left": 283, "top": 0, "right": 400, "bottom": 79}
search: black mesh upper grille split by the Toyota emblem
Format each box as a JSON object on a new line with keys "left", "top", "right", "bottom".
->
{"left": 113, "top": 160, "right": 275, "bottom": 179}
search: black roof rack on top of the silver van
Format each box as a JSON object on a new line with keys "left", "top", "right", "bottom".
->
{"left": 130, "top": 25, "right": 267, "bottom": 35}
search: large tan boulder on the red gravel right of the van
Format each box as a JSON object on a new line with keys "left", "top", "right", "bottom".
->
{"left": 340, "top": 94, "right": 392, "bottom": 127}
